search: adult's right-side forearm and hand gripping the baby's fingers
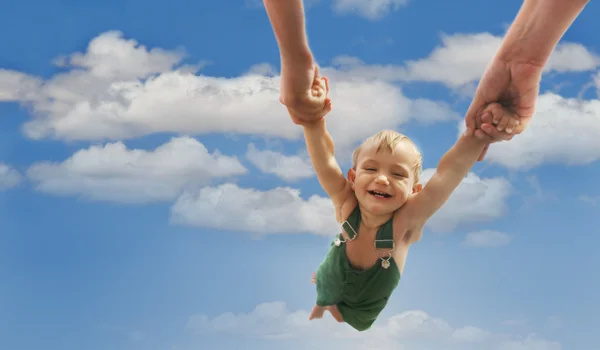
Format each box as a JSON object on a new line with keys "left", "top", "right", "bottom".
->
{"left": 465, "top": 0, "right": 589, "bottom": 160}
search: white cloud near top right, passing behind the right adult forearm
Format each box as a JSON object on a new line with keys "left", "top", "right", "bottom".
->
{"left": 328, "top": 33, "right": 600, "bottom": 89}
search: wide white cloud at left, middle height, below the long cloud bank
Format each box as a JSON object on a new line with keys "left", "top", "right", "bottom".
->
{"left": 27, "top": 137, "right": 247, "bottom": 203}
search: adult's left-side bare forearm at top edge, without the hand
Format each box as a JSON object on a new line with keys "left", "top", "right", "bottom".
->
{"left": 264, "top": 0, "right": 312, "bottom": 61}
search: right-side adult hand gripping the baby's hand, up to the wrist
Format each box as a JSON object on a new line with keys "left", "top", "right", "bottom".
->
{"left": 465, "top": 58, "right": 543, "bottom": 161}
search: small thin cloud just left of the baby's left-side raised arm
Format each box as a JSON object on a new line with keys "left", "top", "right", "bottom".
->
{"left": 246, "top": 144, "right": 315, "bottom": 181}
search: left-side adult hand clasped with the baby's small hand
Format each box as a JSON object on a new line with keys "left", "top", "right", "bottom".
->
{"left": 279, "top": 64, "right": 331, "bottom": 125}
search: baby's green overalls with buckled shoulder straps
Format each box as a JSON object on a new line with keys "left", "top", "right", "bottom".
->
{"left": 316, "top": 205, "right": 400, "bottom": 331}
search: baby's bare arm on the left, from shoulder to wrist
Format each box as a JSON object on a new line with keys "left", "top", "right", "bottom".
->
{"left": 304, "top": 119, "right": 351, "bottom": 208}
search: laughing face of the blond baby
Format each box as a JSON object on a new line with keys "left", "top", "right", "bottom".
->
{"left": 349, "top": 142, "right": 418, "bottom": 215}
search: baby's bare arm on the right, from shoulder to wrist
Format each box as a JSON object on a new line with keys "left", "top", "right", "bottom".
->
{"left": 404, "top": 134, "right": 487, "bottom": 228}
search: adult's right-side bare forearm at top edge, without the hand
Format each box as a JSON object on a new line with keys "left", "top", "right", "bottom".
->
{"left": 497, "top": 0, "right": 589, "bottom": 67}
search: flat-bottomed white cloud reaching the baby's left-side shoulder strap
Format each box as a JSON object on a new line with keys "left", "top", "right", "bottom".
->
{"left": 171, "top": 184, "right": 339, "bottom": 237}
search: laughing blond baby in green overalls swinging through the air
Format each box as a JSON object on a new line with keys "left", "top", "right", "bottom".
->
{"left": 299, "top": 78, "right": 519, "bottom": 331}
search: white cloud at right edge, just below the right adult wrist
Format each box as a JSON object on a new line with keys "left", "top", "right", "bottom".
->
{"left": 474, "top": 93, "right": 600, "bottom": 170}
